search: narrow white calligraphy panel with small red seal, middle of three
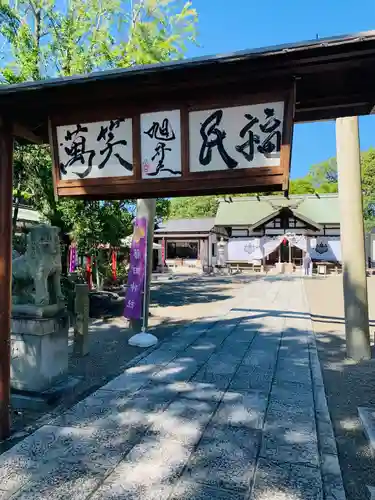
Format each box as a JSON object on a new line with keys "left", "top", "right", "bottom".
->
{"left": 141, "top": 110, "right": 182, "bottom": 179}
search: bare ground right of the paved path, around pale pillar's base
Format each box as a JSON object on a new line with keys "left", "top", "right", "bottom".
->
{"left": 305, "top": 276, "right": 375, "bottom": 500}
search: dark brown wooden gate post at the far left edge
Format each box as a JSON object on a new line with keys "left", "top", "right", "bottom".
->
{"left": 0, "top": 119, "right": 13, "bottom": 440}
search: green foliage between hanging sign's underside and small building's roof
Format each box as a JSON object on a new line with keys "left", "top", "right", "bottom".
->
{"left": 170, "top": 196, "right": 219, "bottom": 219}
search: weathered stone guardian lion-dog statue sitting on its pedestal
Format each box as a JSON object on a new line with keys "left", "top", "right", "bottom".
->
{"left": 12, "top": 225, "right": 64, "bottom": 306}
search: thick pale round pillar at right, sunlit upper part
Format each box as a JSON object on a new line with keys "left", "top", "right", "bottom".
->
{"left": 336, "top": 116, "right": 371, "bottom": 361}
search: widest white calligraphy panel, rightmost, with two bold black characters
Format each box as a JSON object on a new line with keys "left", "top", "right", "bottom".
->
{"left": 189, "top": 102, "right": 284, "bottom": 172}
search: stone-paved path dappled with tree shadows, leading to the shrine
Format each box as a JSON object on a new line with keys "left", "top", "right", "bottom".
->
{"left": 0, "top": 279, "right": 345, "bottom": 500}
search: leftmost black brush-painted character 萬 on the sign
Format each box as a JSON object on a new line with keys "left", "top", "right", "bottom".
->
{"left": 60, "top": 124, "right": 95, "bottom": 179}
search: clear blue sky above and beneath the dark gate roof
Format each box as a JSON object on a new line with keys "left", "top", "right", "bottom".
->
{"left": 188, "top": 0, "right": 375, "bottom": 177}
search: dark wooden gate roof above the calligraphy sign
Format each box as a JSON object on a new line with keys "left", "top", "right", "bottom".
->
{"left": 0, "top": 31, "right": 375, "bottom": 141}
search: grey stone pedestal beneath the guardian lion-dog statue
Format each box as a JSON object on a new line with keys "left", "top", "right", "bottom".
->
{"left": 11, "top": 311, "right": 69, "bottom": 392}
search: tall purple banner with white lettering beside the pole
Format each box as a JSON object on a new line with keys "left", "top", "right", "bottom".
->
{"left": 124, "top": 217, "right": 147, "bottom": 319}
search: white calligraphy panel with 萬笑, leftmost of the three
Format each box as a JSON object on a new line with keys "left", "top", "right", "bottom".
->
{"left": 57, "top": 118, "right": 133, "bottom": 180}
